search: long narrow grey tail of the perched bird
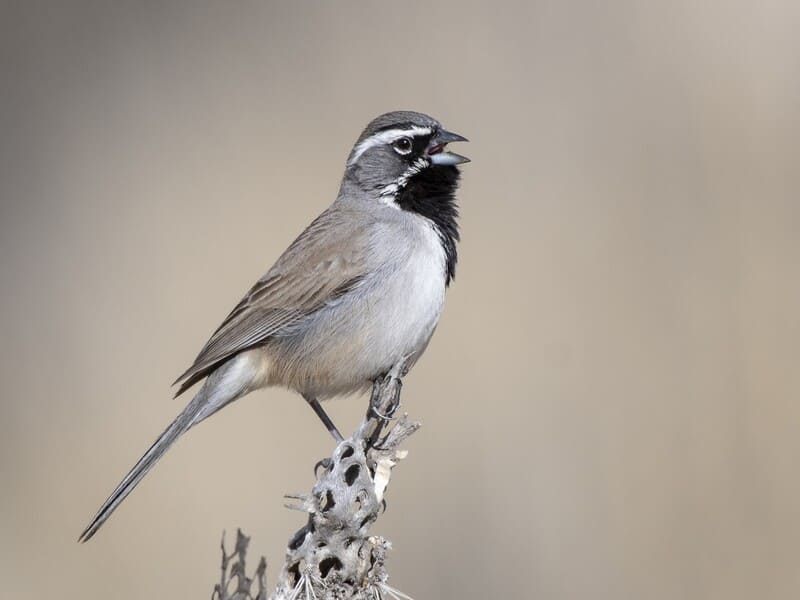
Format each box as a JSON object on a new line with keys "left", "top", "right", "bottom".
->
{"left": 78, "top": 359, "right": 251, "bottom": 542}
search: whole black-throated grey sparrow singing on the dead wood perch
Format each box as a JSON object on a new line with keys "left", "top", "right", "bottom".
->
{"left": 78, "top": 111, "right": 469, "bottom": 542}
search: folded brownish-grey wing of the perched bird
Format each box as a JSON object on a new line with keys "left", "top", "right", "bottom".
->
{"left": 175, "top": 204, "right": 368, "bottom": 396}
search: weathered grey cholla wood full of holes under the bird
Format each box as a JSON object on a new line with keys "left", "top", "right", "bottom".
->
{"left": 212, "top": 365, "right": 419, "bottom": 600}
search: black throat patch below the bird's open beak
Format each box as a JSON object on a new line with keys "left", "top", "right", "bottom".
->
{"left": 394, "top": 166, "right": 461, "bottom": 285}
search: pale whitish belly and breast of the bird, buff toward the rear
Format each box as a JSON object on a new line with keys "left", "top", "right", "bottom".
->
{"left": 263, "top": 218, "right": 445, "bottom": 399}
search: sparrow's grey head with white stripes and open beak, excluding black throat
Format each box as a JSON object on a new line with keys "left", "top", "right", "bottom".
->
{"left": 345, "top": 111, "right": 469, "bottom": 204}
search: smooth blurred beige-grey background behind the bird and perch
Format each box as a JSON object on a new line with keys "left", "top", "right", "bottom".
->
{"left": 0, "top": 0, "right": 800, "bottom": 600}
